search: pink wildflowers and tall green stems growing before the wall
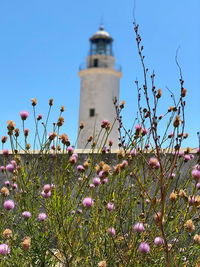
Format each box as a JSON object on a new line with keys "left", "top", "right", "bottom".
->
{"left": 0, "top": 25, "right": 200, "bottom": 267}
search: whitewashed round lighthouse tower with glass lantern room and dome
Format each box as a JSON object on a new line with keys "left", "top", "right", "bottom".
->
{"left": 77, "top": 26, "right": 122, "bottom": 149}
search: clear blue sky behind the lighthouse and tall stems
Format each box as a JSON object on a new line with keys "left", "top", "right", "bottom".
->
{"left": 0, "top": 0, "right": 200, "bottom": 147}
